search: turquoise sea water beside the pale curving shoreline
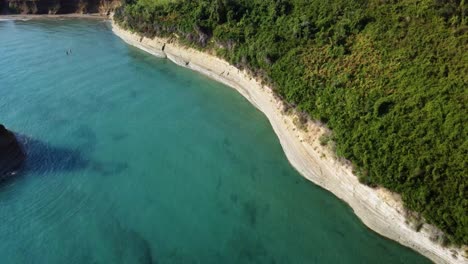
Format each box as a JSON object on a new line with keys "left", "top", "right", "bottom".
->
{"left": 0, "top": 20, "right": 429, "bottom": 263}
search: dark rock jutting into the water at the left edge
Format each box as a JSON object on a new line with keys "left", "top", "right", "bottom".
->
{"left": 0, "top": 125, "right": 25, "bottom": 181}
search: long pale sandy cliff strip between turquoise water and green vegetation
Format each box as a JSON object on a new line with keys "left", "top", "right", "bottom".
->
{"left": 112, "top": 23, "right": 468, "bottom": 263}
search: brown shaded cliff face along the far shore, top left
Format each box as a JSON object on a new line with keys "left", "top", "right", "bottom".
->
{"left": 0, "top": 0, "right": 120, "bottom": 14}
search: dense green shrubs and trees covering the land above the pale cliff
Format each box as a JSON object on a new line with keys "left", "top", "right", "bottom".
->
{"left": 115, "top": 0, "right": 468, "bottom": 244}
